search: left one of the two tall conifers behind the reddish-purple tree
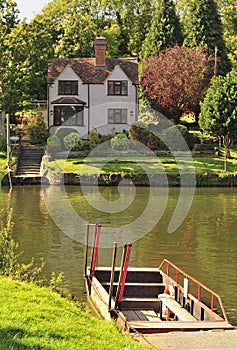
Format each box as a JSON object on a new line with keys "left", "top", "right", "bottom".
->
{"left": 140, "top": 0, "right": 183, "bottom": 60}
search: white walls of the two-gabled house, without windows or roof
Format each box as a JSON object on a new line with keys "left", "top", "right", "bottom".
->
{"left": 48, "top": 66, "right": 137, "bottom": 138}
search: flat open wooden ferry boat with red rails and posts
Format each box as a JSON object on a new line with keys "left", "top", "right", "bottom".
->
{"left": 85, "top": 224, "right": 234, "bottom": 334}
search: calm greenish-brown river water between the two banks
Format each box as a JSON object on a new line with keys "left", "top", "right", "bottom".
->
{"left": 0, "top": 186, "right": 237, "bottom": 325}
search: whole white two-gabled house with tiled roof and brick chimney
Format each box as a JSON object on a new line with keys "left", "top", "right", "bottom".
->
{"left": 48, "top": 37, "right": 138, "bottom": 138}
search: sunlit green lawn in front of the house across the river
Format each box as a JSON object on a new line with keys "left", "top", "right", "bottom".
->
{"left": 45, "top": 152, "right": 237, "bottom": 175}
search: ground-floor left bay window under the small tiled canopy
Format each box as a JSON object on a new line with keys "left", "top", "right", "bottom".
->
{"left": 54, "top": 106, "right": 84, "bottom": 126}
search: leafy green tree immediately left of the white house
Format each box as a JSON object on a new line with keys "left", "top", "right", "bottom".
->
{"left": 7, "top": 15, "right": 54, "bottom": 105}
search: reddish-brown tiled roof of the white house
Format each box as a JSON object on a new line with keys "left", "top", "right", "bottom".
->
{"left": 48, "top": 58, "right": 138, "bottom": 84}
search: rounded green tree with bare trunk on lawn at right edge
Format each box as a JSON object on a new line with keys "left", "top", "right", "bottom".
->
{"left": 199, "top": 71, "right": 237, "bottom": 163}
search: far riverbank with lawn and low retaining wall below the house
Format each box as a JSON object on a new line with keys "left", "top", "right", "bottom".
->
{"left": 0, "top": 149, "right": 237, "bottom": 187}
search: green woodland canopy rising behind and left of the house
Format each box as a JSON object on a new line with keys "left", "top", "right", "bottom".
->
{"left": 0, "top": 0, "right": 237, "bottom": 129}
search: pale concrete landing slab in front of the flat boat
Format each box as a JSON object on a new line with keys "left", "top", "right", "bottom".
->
{"left": 134, "top": 330, "right": 237, "bottom": 350}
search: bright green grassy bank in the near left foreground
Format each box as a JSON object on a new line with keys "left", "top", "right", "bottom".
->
{"left": 0, "top": 277, "right": 149, "bottom": 350}
